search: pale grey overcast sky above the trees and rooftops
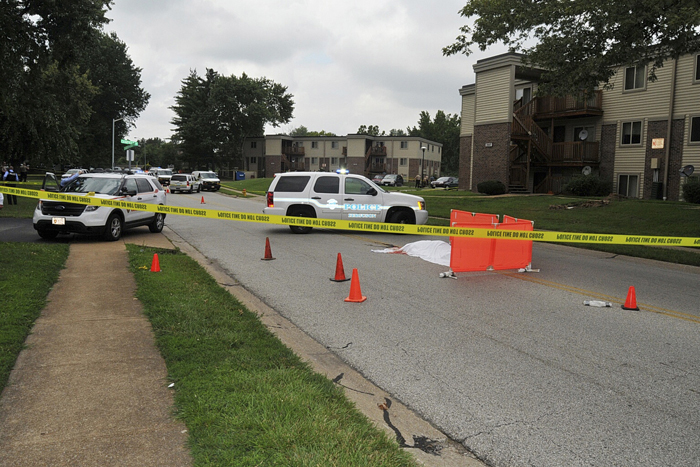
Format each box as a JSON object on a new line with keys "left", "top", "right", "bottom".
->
{"left": 105, "top": 0, "right": 505, "bottom": 139}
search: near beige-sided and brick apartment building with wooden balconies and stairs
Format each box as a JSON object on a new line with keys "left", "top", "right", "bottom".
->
{"left": 460, "top": 53, "right": 700, "bottom": 200}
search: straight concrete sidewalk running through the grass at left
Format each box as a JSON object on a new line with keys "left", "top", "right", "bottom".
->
{"left": 0, "top": 229, "right": 192, "bottom": 466}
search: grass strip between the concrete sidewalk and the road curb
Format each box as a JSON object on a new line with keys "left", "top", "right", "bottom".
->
{"left": 128, "top": 246, "right": 415, "bottom": 466}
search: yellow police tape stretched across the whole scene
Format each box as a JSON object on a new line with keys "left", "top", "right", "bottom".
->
{"left": 0, "top": 185, "right": 700, "bottom": 247}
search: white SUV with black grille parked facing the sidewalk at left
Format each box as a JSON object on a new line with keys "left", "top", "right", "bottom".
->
{"left": 33, "top": 173, "right": 166, "bottom": 241}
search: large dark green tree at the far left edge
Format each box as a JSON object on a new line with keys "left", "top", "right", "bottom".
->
{"left": 0, "top": 0, "right": 147, "bottom": 170}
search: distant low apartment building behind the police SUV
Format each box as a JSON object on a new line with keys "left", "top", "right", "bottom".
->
{"left": 238, "top": 134, "right": 442, "bottom": 182}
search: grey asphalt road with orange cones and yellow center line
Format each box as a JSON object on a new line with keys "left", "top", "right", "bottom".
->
{"left": 166, "top": 193, "right": 700, "bottom": 467}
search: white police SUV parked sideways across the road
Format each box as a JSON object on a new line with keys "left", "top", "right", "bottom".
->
{"left": 263, "top": 171, "right": 428, "bottom": 233}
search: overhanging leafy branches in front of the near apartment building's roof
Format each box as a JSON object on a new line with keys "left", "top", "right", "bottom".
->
{"left": 443, "top": 0, "right": 700, "bottom": 95}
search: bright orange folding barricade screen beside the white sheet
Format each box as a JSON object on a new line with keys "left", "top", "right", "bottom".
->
{"left": 450, "top": 210, "right": 534, "bottom": 272}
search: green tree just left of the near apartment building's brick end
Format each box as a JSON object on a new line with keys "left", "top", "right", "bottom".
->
{"left": 407, "top": 110, "right": 461, "bottom": 175}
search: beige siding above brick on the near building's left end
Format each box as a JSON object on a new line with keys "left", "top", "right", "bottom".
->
{"left": 474, "top": 66, "right": 513, "bottom": 125}
